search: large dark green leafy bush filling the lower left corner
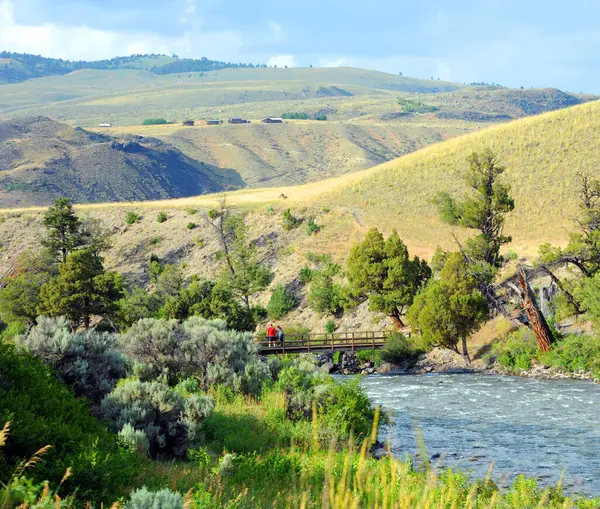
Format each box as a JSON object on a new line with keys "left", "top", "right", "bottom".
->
{"left": 0, "top": 342, "right": 140, "bottom": 503}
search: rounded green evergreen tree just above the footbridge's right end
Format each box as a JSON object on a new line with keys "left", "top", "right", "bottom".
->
{"left": 347, "top": 228, "right": 431, "bottom": 328}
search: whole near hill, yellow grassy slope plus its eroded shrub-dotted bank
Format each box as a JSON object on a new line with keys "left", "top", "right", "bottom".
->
{"left": 0, "top": 102, "right": 600, "bottom": 329}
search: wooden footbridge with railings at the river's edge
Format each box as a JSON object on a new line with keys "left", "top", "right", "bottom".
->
{"left": 255, "top": 331, "right": 391, "bottom": 355}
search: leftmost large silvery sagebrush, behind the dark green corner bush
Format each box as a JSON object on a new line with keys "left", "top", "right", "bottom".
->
{"left": 15, "top": 317, "right": 126, "bottom": 402}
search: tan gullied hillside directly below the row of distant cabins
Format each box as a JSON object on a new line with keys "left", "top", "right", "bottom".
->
{"left": 95, "top": 119, "right": 469, "bottom": 187}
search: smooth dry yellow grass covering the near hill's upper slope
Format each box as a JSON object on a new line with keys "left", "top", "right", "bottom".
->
{"left": 0, "top": 102, "right": 600, "bottom": 255}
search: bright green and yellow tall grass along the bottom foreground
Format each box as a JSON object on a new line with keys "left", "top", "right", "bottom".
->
{"left": 0, "top": 384, "right": 600, "bottom": 509}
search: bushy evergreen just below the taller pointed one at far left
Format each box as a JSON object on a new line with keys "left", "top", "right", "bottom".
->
{"left": 38, "top": 249, "right": 123, "bottom": 329}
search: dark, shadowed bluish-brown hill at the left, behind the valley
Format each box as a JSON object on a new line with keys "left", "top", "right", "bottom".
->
{"left": 0, "top": 117, "right": 229, "bottom": 206}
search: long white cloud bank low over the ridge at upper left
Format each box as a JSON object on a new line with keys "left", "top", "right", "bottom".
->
{"left": 0, "top": 0, "right": 244, "bottom": 60}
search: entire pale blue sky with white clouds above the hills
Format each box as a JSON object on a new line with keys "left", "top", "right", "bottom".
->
{"left": 0, "top": 0, "right": 600, "bottom": 93}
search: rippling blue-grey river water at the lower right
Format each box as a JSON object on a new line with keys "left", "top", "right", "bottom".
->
{"left": 362, "top": 374, "right": 600, "bottom": 497}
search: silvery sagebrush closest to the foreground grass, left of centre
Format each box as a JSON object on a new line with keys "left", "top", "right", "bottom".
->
{"left": 101, "top": 380, "right": 214, "bottom": 458}
